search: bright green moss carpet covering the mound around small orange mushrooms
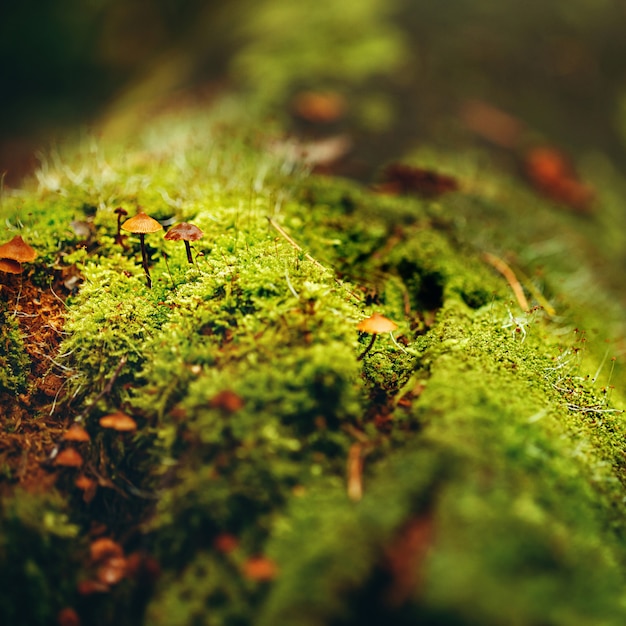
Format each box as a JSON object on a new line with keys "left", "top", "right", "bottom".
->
{"left": 0, "top": 102, "right": 626, "bottom": 626}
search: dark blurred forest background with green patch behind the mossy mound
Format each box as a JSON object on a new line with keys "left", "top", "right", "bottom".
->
{"left": 0, "top": 0, "right": 626, "bottom": 181}
